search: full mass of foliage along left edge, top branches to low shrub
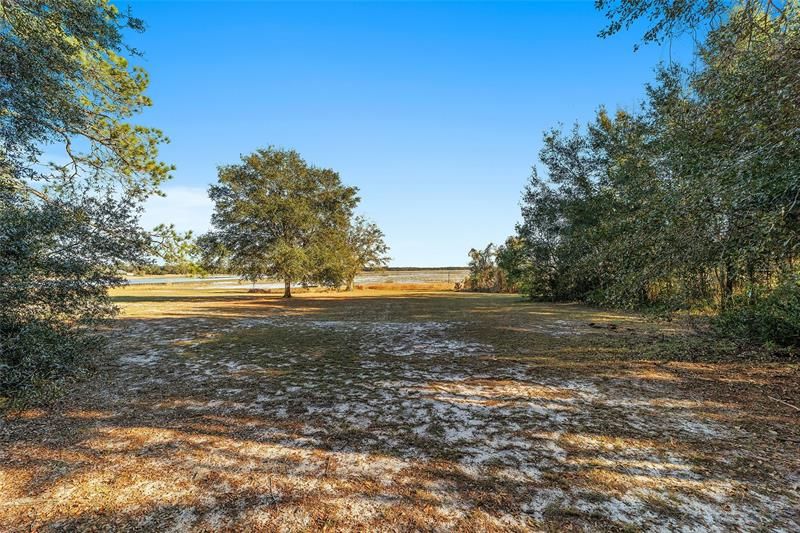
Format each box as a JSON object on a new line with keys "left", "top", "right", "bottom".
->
{"left": 0, "top": 0, "right": 171, "bottom": 397}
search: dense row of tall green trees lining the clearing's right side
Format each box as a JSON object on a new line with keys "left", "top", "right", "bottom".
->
{"left": 468, "top": 0, "right": 800, "bottom": 346}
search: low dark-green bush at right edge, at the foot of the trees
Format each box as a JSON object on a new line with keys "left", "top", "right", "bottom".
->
{"left": 715, "top": 278, "right": 800, "bottom": 347}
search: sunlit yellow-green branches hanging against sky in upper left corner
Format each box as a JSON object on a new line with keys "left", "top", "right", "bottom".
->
{"left": 0, "top": 0, "right": 170, "bottom": 195}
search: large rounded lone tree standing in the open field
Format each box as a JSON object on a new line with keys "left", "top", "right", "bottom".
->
{"left": 209, "top": 147, "right": 359, "bottom": 298}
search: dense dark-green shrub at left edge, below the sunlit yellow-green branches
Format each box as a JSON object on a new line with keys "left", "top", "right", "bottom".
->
{"left": 0, "top": 193, "right": 140, "bottom": 403}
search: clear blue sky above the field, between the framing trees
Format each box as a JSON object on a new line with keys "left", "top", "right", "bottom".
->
{"left": 128, "top": 1, "right": 686, "bottom": 266}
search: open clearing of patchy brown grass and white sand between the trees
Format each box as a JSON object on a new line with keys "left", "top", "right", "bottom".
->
{"left": 0, "top": 284, "right": 800, "bottom": 531}
